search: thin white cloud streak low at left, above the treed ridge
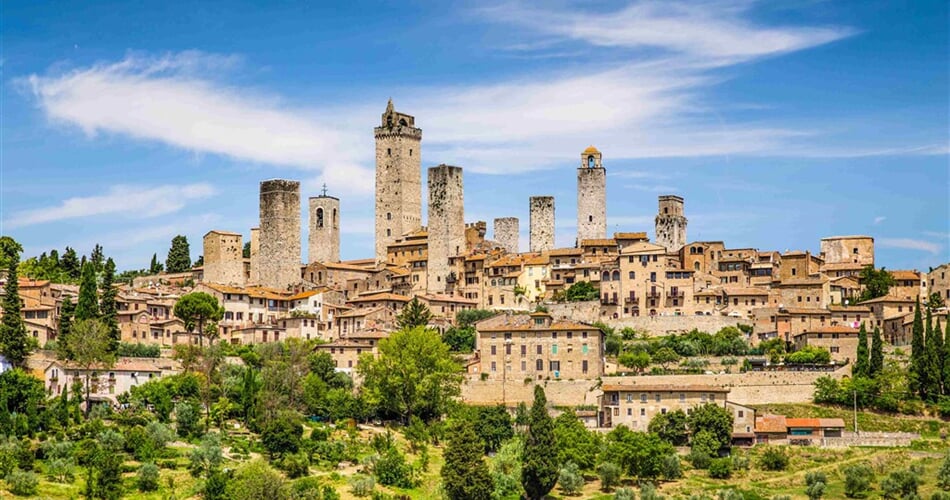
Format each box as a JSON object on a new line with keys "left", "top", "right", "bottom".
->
{"left": 7, "top": 183, "right": 215, "bottom": 228}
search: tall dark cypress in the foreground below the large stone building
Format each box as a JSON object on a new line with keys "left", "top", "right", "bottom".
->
{"left": 521, "top": 385, "right": 558, "bottom": 500}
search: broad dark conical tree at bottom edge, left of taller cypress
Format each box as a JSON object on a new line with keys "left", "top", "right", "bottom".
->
{"left": 439, "top": 419, "right": 494, "bottom": 500}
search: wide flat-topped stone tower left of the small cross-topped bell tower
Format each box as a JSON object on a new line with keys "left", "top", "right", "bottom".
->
{"left": 257, "top": 179, "right": 301, "bottom": 290}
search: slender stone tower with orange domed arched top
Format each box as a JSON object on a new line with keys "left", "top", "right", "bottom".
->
{"left": 577, "top": 146, "right": 607, "bottom": 246}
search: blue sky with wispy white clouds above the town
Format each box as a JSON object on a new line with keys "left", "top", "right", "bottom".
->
{"left": 0, "top": 0, "right": 950, "bottom": 270}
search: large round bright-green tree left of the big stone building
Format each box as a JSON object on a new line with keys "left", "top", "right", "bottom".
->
{"left": 357, "top": 327, "right": 462, "bottom": 422}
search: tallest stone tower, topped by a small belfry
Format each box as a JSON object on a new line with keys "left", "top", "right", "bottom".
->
{"left": 375, "top": 99, "right": 422, "bottom": 262}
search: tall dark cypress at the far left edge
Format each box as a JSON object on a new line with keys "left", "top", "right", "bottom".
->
{"left": 0, "top": 236, "right": 33, "bottom": 366}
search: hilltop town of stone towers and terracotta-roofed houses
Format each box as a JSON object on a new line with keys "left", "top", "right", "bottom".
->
{"left": 0, "top": 101, "right": 950, "bottom": 498}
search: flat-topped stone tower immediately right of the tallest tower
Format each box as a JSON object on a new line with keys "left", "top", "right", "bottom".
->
{"left": 426, "top": 165, "right": 465, "bottom": 293}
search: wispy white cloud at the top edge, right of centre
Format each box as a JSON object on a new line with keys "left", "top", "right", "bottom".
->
{"left": 480, "top": 0, "right": 854, "bottom": 64}
